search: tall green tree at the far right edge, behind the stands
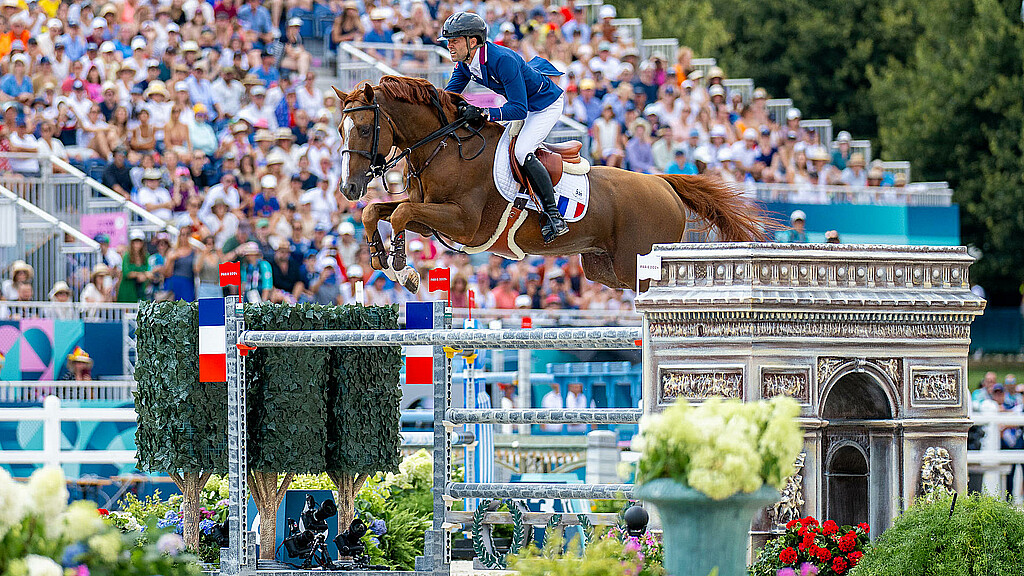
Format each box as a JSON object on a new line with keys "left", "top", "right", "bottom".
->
{"left": 870, "top": 0, "right": 1024, "bottom": 297}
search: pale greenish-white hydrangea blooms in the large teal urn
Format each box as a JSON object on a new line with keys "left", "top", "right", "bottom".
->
{"left": 637, "top": 397, "right": 803, "bottom": 500}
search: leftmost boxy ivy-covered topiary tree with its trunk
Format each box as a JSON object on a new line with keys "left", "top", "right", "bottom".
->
{"left": 135, "top": 302, "right": 227, "bottom": 549}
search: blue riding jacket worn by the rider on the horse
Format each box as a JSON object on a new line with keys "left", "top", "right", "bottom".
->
{"left": 444, "top": 42, "right": 562, "bottom": 122}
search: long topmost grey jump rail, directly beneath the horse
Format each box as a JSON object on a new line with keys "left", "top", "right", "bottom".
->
{"left": 239, "top": 327, "right": 643, "bottom": 349}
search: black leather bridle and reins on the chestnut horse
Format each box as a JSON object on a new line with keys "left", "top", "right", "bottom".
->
{"left": 341, "top": 84, "right": 486, "bottom": 187}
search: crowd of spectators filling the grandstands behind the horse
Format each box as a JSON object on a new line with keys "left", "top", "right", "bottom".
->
{"left": 0, "top": 0, "right": 905, "bottom": 310}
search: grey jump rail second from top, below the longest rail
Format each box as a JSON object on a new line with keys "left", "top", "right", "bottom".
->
{"left": 447, "top": 408, "right": 643, "bottom": 424}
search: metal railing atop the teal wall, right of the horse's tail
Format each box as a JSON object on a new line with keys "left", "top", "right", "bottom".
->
{"left": 749, "top": 182, "right": 953, "bottom": 206}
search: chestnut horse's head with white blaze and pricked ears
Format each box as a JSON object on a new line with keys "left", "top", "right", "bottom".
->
{"left": 334, "top": 84, "right": 395, "bottom": 200}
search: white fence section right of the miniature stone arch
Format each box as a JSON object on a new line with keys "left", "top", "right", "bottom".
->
{"left": 967, "top": 413, "right": 1024, "bottom": 504}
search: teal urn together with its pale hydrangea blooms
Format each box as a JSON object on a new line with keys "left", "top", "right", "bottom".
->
{"left": 634, "top": 397, "right": 803, "bottom": 576}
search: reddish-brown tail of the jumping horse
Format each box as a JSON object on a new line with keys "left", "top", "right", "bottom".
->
{"left": 658, "top": 174, "right": 772, "bottom": 242}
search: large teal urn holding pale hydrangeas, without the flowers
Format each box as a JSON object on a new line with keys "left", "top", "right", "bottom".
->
{"left": 633, "top": 479, "right": 778, "bottom": 576}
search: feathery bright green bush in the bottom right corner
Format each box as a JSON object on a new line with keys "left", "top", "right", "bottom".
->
{"left": 852, "top": 487, "right": 1024, "bottom": 576}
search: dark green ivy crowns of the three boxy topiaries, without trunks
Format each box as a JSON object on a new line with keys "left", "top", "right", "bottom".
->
{"left": 135, "top": 302, "right": 401, "bottom": 474}
